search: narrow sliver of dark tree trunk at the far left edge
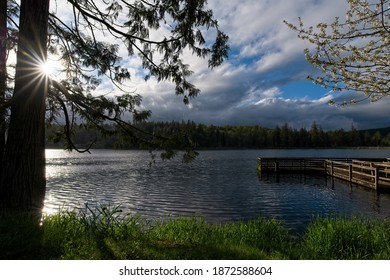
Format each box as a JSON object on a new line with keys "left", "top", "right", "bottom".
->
{"left": 0, "top": 1, "right": 7, "bottom": 182}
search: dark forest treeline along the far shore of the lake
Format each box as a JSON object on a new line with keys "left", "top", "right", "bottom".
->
{"left": 47, "top": 122, "right": 390, "bottom": 149}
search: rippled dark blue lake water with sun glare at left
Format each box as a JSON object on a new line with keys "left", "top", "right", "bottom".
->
{"left": 44, "top": 149, "right": 390, "bottom": 231}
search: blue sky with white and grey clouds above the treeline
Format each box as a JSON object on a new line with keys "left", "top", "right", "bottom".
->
{"left": 52, "top": 0, "right": 390, "bottom": 130}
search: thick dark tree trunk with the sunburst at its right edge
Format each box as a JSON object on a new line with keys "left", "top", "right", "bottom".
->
{"left": 0, "top": 0, "right": 49, "bottom": 212}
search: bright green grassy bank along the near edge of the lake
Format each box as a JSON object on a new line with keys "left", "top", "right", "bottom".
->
{"left": 0, "top": 207, "right": 390, "bottom": 260}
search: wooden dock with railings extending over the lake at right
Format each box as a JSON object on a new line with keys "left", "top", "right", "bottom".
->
{"left": 257, "top": 157, "right": 390, "bottom": 190}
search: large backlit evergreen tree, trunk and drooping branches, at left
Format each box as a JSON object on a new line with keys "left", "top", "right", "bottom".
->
{"left": 0, "top": 0, "right": 229, "bottom": 209}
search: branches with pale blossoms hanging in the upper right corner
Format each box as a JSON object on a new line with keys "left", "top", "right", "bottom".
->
{"left": 287, "top": 0, "right": 390, "bottom": 105}
